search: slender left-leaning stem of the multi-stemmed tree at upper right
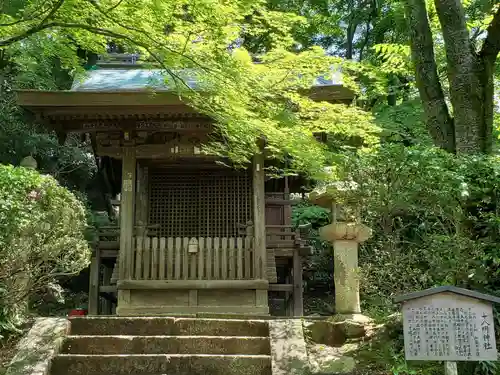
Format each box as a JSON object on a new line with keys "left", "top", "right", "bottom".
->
{"left": 405, "top": 0, "right": 455, "bottom": 152}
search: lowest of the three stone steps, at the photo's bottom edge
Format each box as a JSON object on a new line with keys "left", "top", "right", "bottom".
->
{"left": 51, "top": 354, "right": 272, "bottom": 375}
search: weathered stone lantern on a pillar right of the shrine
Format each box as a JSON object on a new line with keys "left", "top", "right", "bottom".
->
{"left": 309, "top": 183, "right": 372, "bottom": 314}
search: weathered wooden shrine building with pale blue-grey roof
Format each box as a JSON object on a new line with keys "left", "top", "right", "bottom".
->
{"left": 18, "top": 56, "right": 353, "bottom": 316}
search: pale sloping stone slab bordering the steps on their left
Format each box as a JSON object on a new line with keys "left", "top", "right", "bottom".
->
{"left": 5, "top": 318, "right": 69, "bottom": 375}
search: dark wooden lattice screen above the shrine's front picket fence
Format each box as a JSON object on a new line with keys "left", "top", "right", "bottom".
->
{"left": 149, "top": 168, "right": 252, "bottom": 237}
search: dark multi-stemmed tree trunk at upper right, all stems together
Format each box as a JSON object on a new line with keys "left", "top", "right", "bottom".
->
{"left": 405, "top": 0, "right": 500, "bottom": 154}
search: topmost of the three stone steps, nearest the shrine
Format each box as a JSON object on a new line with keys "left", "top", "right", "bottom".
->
{"left": 70, "top": 317, "right": 269, "bottom": 337}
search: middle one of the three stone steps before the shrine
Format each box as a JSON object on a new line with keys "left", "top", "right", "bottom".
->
{"left": 62, "top": 336, "right": 271, "bottom": 355}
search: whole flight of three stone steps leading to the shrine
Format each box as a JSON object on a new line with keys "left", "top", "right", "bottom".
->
{"left": 50, "top": 317, "right": 271, "bottom": 375}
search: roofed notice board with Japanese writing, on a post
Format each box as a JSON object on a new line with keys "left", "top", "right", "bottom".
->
{"left": 395, "top": 286, "right": 500, "bottom": 375}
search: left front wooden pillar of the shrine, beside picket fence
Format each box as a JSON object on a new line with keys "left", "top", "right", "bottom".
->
{"left": 119, "top": 146, "right": 136, "bottom": 280}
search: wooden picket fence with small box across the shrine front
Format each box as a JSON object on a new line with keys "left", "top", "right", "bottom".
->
{"left": 129, "top": 236, "right": 255, "bottom": 280}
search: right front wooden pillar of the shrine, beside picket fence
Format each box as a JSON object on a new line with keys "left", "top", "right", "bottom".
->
{"left": 253, "top": 152, "right": 267, "bottom": 279}
